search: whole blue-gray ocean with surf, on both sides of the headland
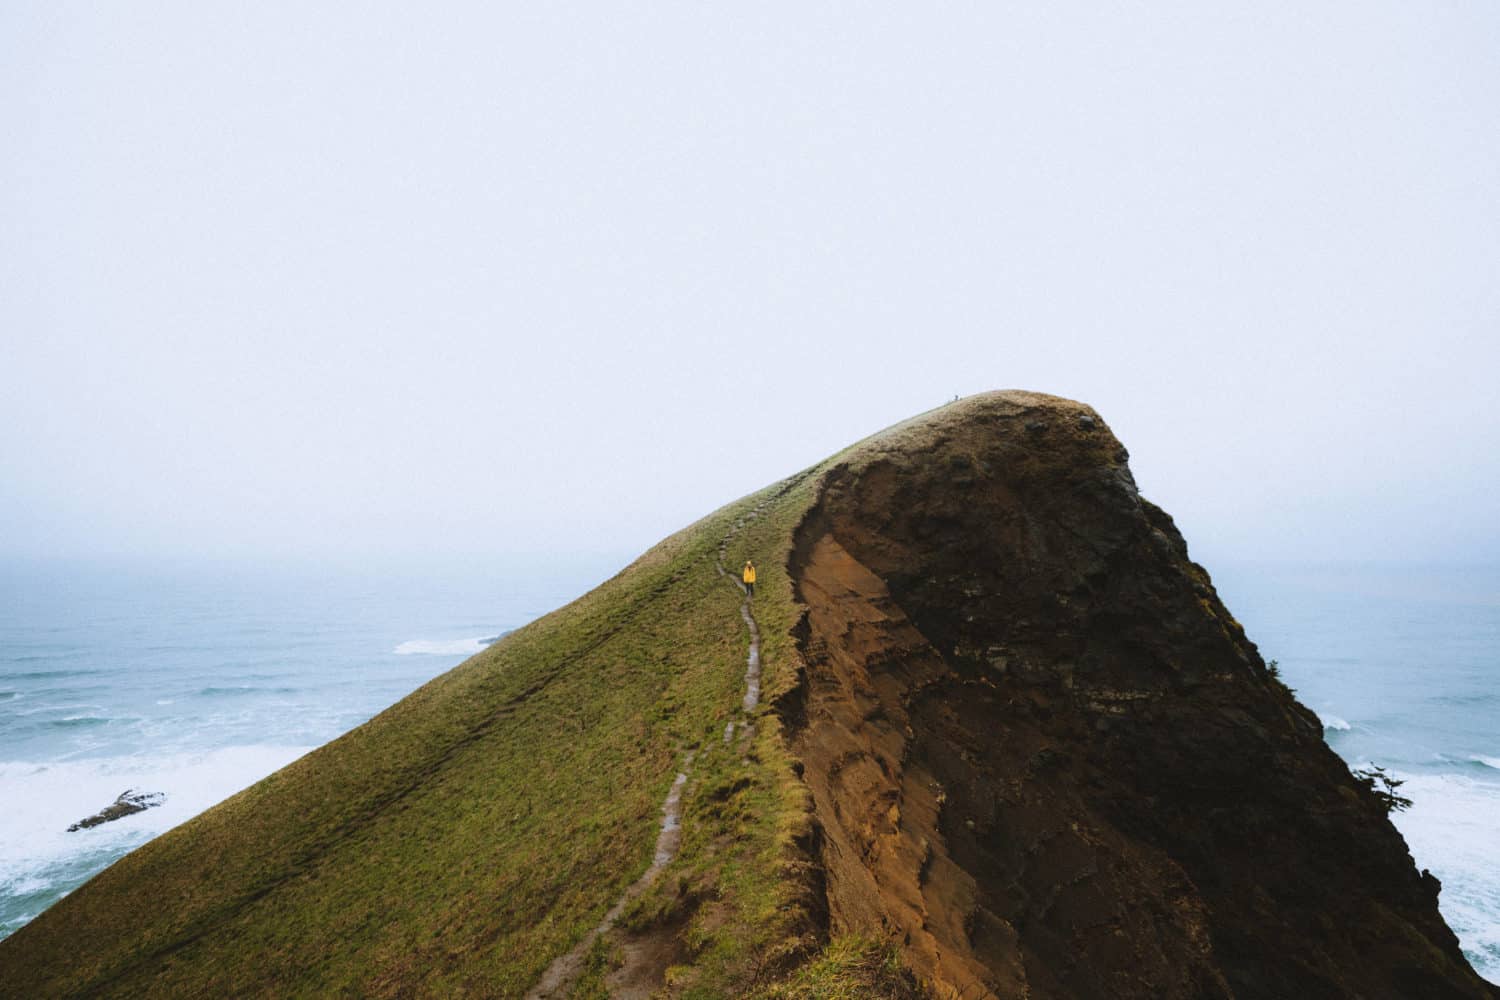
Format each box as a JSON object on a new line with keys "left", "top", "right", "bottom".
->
{"left": 0, "top": 558, "right": 1500, "bottom": 981}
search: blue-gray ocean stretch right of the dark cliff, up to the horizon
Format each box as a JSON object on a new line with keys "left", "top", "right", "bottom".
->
{"left": 1209, "top": 565, "right": 1500, "bottom": 982}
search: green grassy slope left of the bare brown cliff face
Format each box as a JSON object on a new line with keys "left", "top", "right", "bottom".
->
{"left": 0, "top": 475, "right": 834, "bottom": 997}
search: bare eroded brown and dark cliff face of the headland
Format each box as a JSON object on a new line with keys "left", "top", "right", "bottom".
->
{"left": 786, "top": 393, "right": 1497, "bottom": 999}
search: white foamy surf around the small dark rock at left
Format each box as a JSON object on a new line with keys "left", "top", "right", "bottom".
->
{"left": 0, "top": 747, "right": 311, "bottom": 906}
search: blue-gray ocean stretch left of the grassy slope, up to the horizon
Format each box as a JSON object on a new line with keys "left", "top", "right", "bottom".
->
{"left": 0, "top": 556, "right": 624, "bottom": 937}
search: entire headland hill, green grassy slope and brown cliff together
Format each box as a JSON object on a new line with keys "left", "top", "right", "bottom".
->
{"left": 0, "top": 393, "right": 1496, "bottom": 1000}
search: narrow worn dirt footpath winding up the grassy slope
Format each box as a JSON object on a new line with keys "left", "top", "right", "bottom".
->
{"left": 525, "top": 502, "right": 765, "bottom": 1000}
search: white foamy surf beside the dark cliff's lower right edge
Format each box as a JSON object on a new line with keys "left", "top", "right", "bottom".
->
{"left": 1392, "top": 774, "right": 1500, "bottom": 982}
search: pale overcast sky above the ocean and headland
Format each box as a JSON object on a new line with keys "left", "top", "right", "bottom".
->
{"left": 0, "top": 0, "right": 1500, "bottom": 562}
